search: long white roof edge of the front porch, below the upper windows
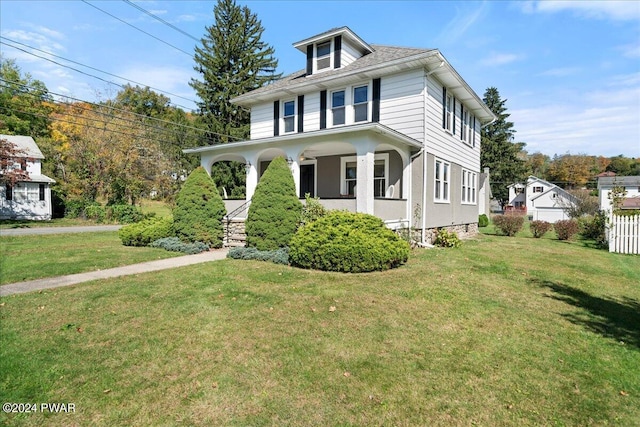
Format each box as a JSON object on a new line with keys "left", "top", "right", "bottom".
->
{"left": 182, "top": 123, "right": 423, "bottom": 155}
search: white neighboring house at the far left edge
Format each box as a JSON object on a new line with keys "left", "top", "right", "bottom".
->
{"left": 0, "top": 135, "right": 55, "bottom": 220}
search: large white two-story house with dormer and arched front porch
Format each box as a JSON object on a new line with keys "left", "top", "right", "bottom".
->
{"left": 185, "top": 27, "right": 495, "bottom": 243}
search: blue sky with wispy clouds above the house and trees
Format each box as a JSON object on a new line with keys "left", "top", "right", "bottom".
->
{"left": 0, "top": 0, "right": 640, "bottom": 157}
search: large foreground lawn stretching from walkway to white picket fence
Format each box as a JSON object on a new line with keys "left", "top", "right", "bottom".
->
{"left": 0, "top": 235, "right": 640, "bottom": 426}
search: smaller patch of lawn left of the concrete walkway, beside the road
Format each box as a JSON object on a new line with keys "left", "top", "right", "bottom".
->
{"left": 0, "top": 232, "right": 182, "bottom": 284}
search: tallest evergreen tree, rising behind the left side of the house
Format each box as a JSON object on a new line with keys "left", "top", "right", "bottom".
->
{"left": 190, "top": 0, "right": 280, "bottom": 143}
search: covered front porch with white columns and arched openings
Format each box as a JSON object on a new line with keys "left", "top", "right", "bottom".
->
{"left": 186, "top": 123, "right": 422, "bottom": 228}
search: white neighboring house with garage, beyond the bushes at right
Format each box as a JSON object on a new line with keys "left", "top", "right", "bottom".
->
{"left": 507, "top": 176, "right": 575, "bottom": 222}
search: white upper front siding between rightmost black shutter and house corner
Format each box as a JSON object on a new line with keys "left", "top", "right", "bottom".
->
{"left": 380, "top": 70, "right": 425, "bottom": 142}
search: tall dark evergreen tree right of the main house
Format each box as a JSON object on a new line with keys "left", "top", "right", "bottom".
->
{"left": 480, "top": 87, "right": 527, "bottom": 206}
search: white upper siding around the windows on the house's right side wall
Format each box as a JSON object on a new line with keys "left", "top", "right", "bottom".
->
{"left": 425, "top": 77, "right": 480, "bottom": 172}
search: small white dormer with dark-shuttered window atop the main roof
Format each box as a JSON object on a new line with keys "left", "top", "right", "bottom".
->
{"left": 293, "top": 27, "right": 373, "bottom": 76}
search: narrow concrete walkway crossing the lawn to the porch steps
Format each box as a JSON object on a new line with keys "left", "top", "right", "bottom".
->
{"left": 0, "top": 249, "right": 228, "bottom": 297}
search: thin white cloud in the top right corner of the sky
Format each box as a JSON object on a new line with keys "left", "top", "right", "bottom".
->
{"left": 521, "top": 0, "right": 640, "bottom": 21}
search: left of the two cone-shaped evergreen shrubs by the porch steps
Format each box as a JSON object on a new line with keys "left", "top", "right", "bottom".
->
{"left": 173, "top": 166, "right": 226, "bottom": 248}
